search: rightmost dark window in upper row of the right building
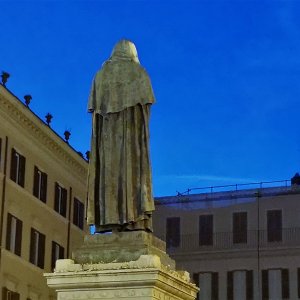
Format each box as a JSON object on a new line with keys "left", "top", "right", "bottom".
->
{"left": 267, "top": 210, "right": 282, "bottom": 242}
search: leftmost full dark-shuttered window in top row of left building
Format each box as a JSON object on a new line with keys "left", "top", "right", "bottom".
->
{"left": 10, "top": 148, "right": 26, "bottom": 187}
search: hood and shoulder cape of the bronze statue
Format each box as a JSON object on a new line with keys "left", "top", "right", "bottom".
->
{"left": 88, "top": 40, "right": 155, "bottom": 114}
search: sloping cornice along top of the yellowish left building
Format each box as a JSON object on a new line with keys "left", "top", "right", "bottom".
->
{"left": 0, "top": 85, "right": 87, "bottom": 178}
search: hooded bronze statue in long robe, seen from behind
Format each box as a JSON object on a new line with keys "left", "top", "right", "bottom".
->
{"left": 87, "top": 40, "right": 155, "bottom": 232}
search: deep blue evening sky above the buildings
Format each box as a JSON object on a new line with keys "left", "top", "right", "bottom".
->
{"left": 0, "top": 0, "right": 300, "bottom": 196}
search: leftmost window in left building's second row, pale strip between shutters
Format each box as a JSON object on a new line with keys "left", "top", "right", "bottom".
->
{"left": 6, "top": 213, "right": 22, "bottom": 256}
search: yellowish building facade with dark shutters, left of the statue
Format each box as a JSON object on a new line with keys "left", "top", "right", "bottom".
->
{"left": 0, "top": 85, "right": 88, "bottom": 300}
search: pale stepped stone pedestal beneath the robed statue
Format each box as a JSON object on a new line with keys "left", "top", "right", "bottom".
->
{"left": 45, "top": 231, "right": 198, "bottom": 300}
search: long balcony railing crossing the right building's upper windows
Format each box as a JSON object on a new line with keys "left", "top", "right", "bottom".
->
{"left": 160, "top": 227, "right": 300, "bottom": 254}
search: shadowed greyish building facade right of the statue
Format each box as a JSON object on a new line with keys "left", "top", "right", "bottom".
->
{"left": 154, "top": 180, "right": 300, "bottom": 300}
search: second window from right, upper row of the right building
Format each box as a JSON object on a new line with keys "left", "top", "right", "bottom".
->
{"left": 232, "top": 212, "right": 247, "bottom": 244}
